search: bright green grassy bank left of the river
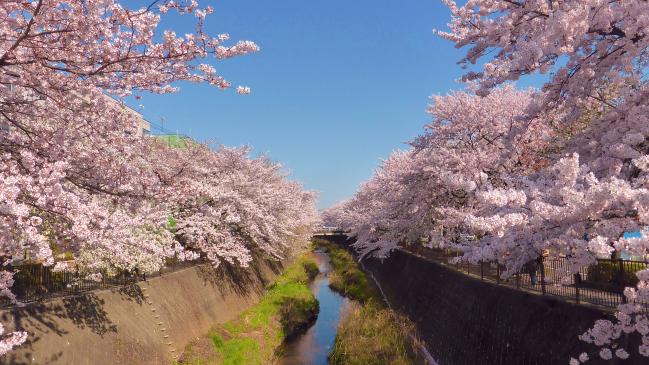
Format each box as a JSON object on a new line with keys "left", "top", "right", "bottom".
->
{"left": 178, "top": 255, "right": 319, "bottom": 365}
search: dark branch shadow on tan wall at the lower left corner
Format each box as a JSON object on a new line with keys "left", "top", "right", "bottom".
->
{"left": 0, "top": 293, "right": 117, "bottom": 365}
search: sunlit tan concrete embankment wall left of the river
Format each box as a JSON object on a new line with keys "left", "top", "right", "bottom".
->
{"left": 0, "top": 260, "right": 281, "bottom": 365}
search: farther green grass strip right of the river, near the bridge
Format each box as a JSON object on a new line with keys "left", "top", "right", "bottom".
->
{"left": 313, "top": 238, "right": 381, "bottom": 303}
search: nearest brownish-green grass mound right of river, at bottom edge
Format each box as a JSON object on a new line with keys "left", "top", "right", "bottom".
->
{"left": 329, "top": 301, "right": 425, "bottom": 365}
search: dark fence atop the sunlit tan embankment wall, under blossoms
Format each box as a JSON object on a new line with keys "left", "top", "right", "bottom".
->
{"left": 0, "top": 260, "right": 205, "bottom": 308}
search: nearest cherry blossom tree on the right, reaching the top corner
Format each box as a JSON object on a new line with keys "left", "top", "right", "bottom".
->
{"left": 439, "top": 0, "right": 649, "bottom": 361}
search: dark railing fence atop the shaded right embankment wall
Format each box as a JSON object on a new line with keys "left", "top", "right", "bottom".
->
{"left": 406, "top": 246, "right": 649, "bottom": 310}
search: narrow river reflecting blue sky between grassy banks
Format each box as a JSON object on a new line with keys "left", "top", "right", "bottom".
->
{"left": 279, "top": 251, "right": 350, "bottom": 365}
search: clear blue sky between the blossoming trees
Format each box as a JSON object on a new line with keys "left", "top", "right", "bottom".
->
{"left": 127, "top": 0, "right": 480, "bottom": 208}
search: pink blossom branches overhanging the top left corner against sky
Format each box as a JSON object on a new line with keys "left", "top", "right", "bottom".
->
{"left": 0, "top": 0, "right": 258, "bottom": 98}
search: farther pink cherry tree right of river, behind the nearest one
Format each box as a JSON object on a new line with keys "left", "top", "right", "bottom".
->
{"left": 325, "top": 85, "right": 554, "bottom": 256}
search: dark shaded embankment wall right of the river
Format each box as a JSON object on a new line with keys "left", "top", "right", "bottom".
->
{"left": 364, "top": 251, "right": 649, "bottom": 365}
